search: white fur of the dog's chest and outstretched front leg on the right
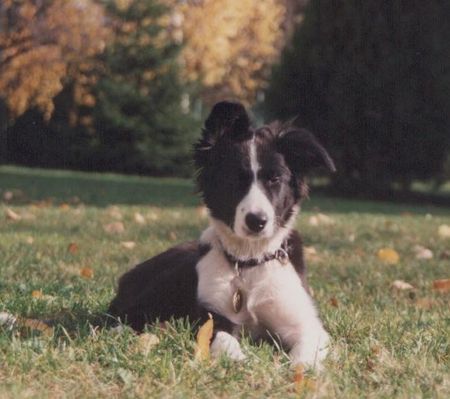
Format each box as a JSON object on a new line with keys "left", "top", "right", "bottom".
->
{"left": 197, "top": 228, "right": 329, "bottom": 368}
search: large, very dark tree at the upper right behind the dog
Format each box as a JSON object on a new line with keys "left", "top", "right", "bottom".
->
{"left": 266, "top": 0, "right": 450, "bottom": 195}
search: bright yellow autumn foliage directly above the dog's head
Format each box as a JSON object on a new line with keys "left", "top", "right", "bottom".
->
{"left": 171, "top": 0, "right": 286, "bottom": 104}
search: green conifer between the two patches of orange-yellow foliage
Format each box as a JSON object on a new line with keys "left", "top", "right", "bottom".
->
{"left": 94, "top": 0, "right": 197, "bottom": 174}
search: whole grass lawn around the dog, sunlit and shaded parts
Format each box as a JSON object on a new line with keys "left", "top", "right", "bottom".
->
{"left": 0, "top": 167, "right": 450, "bottom": 398}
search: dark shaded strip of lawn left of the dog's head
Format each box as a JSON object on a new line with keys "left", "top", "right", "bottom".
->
{"left": 0, "top": 167, "right": 200, "bottom": 207}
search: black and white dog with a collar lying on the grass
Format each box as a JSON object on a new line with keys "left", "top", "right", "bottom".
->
{"left": 109, "top": 102, "right": 334, "bottom": 366}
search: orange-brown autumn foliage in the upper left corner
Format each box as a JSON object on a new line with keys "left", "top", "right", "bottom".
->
{"left": 0, "top": 0, "right": 108, "bottom": 119}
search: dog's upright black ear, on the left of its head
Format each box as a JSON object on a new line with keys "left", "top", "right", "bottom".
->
{"left": 203, "top": 101, "right": 250, "bottom": 145}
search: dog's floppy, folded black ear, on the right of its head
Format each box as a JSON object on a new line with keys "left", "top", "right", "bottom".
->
{"left": 277, "top": 127, "right": 336, "bottom": 175}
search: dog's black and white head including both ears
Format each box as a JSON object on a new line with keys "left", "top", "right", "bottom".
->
{"left": 194, "top": 102, "right": 335, "bottom": 240}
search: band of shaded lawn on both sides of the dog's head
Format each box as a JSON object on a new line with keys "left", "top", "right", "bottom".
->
{"left": 0, "top": 166, "right": 450, "bottom": 215}
